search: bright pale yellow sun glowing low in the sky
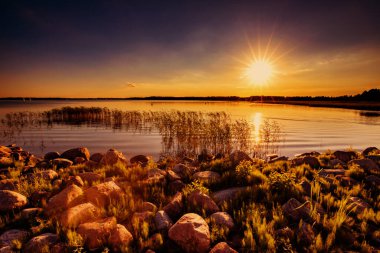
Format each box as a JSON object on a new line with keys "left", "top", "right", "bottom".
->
{"left": 243, "top": 59, "right": 274, "bottom": 85}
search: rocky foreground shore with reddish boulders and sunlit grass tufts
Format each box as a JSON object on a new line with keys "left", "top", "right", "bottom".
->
{"left": 0, "top": 145, "right": 380, "bottom": 253}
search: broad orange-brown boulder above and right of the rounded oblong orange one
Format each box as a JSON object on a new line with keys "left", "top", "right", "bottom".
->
{"left": 84, "top": 181, "right": 123, "bottom": 208}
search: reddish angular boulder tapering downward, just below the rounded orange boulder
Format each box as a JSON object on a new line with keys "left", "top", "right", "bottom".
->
{"left": 77, "top": 217, "right": 117, "bottom": 250}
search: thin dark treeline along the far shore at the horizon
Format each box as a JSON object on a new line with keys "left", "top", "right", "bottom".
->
{"left": 0, "top": 89, "right": 380, "bottom": 102}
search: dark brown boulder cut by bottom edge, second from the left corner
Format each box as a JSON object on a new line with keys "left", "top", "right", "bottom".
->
{"left": 23, "top": 233, "right": 59, "bottom": 253}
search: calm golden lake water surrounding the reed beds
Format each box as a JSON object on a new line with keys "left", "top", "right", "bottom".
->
{"left": 0, "top": 101, "right": 380, "bottom": 157}
